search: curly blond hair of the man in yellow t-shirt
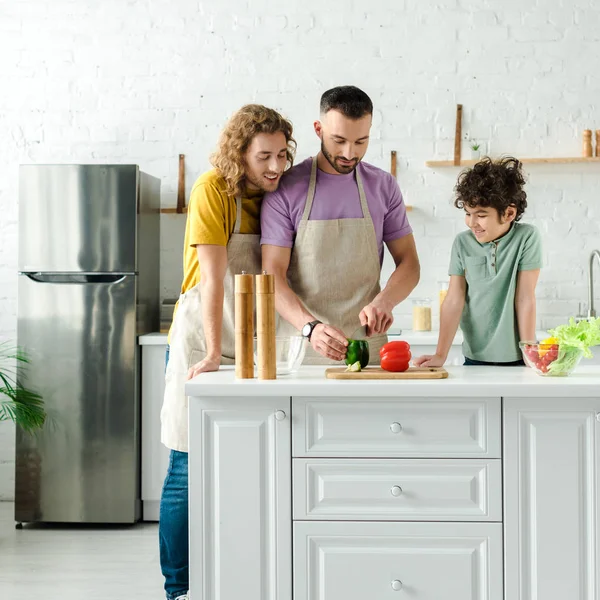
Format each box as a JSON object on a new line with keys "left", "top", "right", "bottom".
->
{"left": 210, "top": 104, "right": 296, "bottom": 196}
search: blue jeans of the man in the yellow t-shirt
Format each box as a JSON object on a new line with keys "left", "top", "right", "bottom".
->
{"left": 158, "top": 346, "right": 190, "bottom": 600}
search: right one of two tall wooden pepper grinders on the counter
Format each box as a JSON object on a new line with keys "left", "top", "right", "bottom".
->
{"left": 256, "top": 271, "right": 277, "bottom": 379}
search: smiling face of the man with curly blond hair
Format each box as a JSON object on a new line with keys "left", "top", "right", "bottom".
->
{"left": 244, "top": 131, "right": 287, "bottom": 192}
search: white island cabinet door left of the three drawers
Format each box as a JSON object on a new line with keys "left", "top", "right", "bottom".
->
{"left": 189, "top": 397, "right": 292, "bottom": 600}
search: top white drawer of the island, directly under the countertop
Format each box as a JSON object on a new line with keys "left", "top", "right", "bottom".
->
{"left": 292, "top": 397, "right": 500, "bottom": 458}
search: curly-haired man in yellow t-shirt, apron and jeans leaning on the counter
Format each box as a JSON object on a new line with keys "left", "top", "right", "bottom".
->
{"left": 159, "top": 104, "right": 296, "bottom": 600}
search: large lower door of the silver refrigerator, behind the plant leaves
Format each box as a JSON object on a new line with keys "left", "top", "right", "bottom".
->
{"left": 15, "top": 274, "right": 140, "bottom": 523}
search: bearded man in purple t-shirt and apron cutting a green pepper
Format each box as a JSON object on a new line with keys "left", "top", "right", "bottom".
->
{"left": 261, "top": 86, "right": 420, "bottom": 364}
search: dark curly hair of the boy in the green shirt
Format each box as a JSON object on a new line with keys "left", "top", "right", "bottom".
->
{"left": 454, "top": 156, "right": 527, "bottom": 221}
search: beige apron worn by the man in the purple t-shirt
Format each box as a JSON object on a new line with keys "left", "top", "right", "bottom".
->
{"left": 278, "top": 158, "right": 387, "bottom": 365}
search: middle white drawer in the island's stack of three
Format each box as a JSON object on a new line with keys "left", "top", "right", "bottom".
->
{"left": 293, "top": 458, "right": 502, "bottom": 521}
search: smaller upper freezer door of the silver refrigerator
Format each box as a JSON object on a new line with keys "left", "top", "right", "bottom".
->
{"left": 18, "top": 165, "right": 139, "bottom": 273}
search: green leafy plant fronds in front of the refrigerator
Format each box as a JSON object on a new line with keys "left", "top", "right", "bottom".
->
{"left": 0, "top": 342, "right": 46, "bottom": 432}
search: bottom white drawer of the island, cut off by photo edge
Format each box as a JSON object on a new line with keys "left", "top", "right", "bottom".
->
{"left": 294, "top": 522, "right": 503, "bottom": 600}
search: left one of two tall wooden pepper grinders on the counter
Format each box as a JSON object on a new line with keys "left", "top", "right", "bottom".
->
{"left": 235, "top": 271, "right": 254, "bottom": 379}
